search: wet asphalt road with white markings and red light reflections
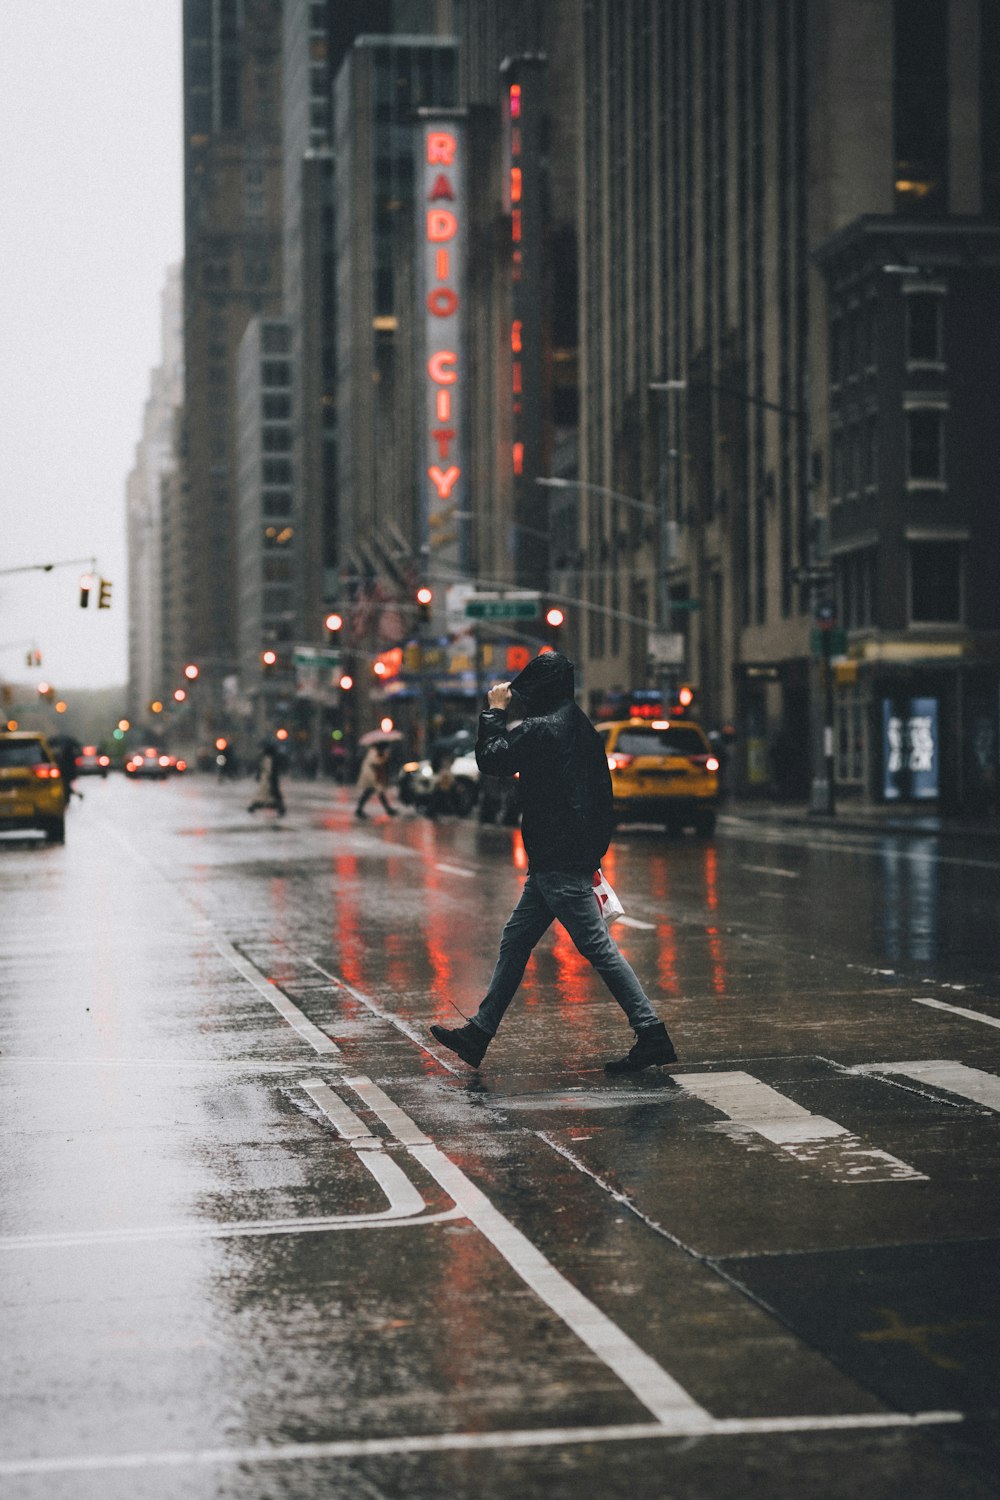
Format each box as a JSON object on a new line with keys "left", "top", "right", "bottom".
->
{"left": 0, "top": 777, "right": 1000, "bottom": 1500}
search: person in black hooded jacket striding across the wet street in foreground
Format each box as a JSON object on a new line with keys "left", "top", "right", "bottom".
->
{"left": 430, "top": 651, "right": 676, "bottom": 1073}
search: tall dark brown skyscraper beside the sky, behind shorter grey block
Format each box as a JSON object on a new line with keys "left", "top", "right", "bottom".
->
{"left": 175, "top": 0, "right": 284, "bottom": 707}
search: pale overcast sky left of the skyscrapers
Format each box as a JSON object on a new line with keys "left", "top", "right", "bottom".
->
{"left": 0, "top": 0, "right": 183, "bottom": 692}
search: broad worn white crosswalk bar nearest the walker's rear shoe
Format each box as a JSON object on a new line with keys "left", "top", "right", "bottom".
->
{"left": 672, "top": 1073, "right": 927, "bottom": 1184}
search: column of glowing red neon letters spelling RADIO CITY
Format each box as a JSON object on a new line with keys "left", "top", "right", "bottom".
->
{"left": 424, "top": 129, "right": 462, "bottom": 501}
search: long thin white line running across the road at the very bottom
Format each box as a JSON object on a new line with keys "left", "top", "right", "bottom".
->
{"left": 0, "top": 1412, "right": 964, "bottom": 1479}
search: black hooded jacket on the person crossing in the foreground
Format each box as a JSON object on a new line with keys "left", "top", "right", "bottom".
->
{"left": 475, "top": 651, "right": 615, "bottom": 875}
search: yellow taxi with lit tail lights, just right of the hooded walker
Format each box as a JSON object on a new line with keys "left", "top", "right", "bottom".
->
{"left": 595, "top": 717, "right": 718, "bottom": 836}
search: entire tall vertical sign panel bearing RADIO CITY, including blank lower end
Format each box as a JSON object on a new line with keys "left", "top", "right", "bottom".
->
{"left": 417, "top": 116, "right": 469, "bottom": 572}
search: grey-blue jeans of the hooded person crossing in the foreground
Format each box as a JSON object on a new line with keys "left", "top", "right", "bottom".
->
{"left": 472, "top": 870, "right": 660, "bottom": 1037}
